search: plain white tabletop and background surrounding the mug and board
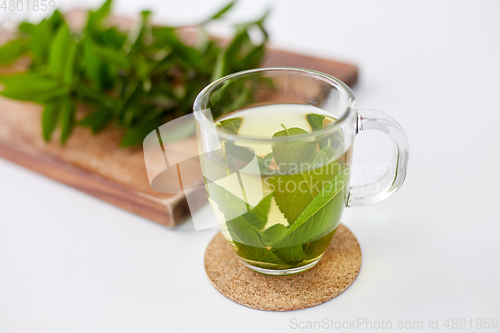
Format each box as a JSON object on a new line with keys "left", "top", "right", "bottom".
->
{"left": 0, "top": 0, "right": 500, "bottom": 333}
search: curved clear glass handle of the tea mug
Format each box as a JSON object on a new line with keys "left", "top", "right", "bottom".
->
{"left": 347, "top": 110, "right": 410, "bottom": 207}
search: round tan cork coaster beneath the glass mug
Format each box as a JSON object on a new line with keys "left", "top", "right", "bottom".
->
{"left": 205, "top": 224, "right": 361, "bottom": 311}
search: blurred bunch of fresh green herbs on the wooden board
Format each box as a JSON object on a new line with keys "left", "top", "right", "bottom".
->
{"left": 0, "top": 0, "right": 268, "bottom": 147}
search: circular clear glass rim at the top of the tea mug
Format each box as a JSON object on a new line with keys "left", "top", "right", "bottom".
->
{"left": 193, "top": 67, "right": 356, "bottom": 142}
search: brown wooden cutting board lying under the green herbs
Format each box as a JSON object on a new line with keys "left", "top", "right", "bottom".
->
{"left": 0, "top": 11, "right": 358, "bottom": 227}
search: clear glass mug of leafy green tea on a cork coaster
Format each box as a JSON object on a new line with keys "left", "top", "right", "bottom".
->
{"left": 194, "top": 68, "right": 409, "bottom": 275}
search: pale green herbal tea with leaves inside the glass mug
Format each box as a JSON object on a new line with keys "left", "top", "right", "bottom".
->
{"left": 206, "top": 104, "right": 351, "bottom": 273}
